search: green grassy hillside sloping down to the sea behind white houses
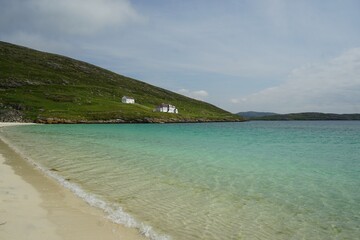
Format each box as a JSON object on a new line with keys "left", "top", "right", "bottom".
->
{"left": 0, "top": 41, "right": 242, "bottom": 123}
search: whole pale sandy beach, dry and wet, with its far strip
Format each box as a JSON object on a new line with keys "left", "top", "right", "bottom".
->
{"left": 0, "top": 123, "right": 144, "bottom": 240}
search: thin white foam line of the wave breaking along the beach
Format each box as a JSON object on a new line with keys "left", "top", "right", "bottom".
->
{"left": 0, "top": 136, "right": 171, "bottom": 240}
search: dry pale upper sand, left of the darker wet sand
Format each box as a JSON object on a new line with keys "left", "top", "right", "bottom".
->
{"left": 0, "top": 154, "right": 61, "bottom": 240}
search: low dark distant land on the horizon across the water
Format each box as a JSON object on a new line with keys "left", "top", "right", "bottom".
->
{"left": 237, "top": 112, "right": 360, "bottom": 121}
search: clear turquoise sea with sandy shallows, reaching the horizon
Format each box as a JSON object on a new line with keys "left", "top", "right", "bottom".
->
{"left": 0, "top": 121, "right": 360, "bottom": 239}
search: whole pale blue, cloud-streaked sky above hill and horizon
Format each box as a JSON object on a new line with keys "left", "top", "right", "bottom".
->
{"left": 0, "top": 0, "right": 360, "bottom": 113}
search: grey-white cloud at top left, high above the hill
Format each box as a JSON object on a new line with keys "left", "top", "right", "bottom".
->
{"left": 0, "top": 0, "right": 142, "bottom": 35}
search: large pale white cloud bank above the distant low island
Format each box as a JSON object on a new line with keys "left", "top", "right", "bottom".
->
{"left": 232, "top": 48, "right": 360, "bottom": 113}
